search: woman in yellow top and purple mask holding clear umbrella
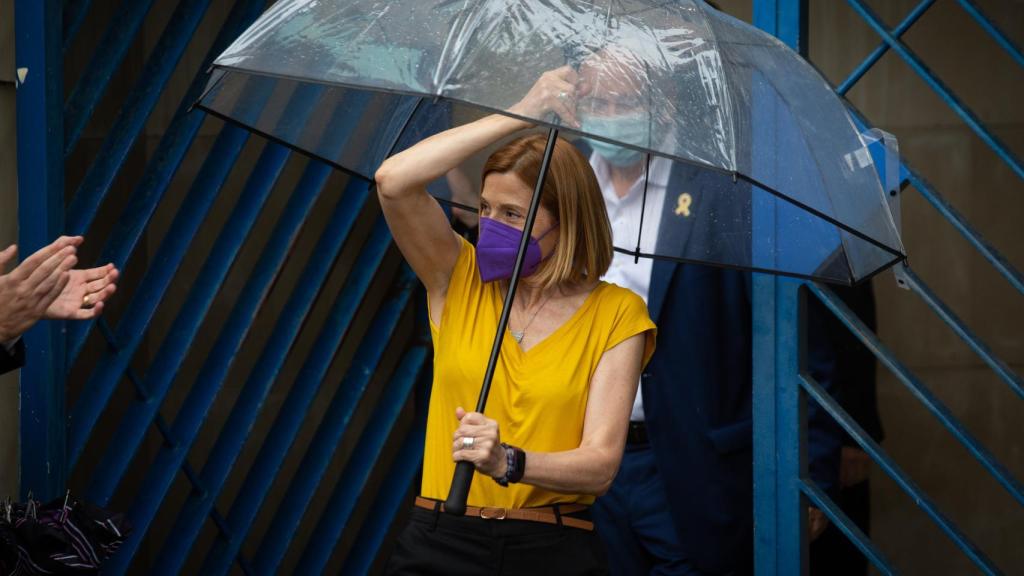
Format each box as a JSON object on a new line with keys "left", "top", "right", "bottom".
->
{"left": 376, "top": 68, "right": 654, "bottom": 575}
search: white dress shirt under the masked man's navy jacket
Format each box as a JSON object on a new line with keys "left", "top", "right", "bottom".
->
{"left": 590, "top": 153, "right": 672, "bottom": 421}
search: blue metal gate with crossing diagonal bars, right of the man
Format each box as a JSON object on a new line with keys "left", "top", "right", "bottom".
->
{"left": 754, "top": 0, "right": 1024, "bottom": 575}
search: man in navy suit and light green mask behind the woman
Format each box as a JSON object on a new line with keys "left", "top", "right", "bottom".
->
{"left": 570, "top": 42, "right": 841, "bottom": 575}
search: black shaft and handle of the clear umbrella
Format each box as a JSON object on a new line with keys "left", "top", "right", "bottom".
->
{"left": 444, "top": 128, "right": 558, "bottom": 516}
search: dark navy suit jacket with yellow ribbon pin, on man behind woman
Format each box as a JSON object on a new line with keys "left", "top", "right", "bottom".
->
{"left": 581, "top": 147, "right": 842, "bottom": 574}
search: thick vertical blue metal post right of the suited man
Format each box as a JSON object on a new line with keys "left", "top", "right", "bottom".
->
{"left": 752, "top": 0, "right": 807, "bottom": 576}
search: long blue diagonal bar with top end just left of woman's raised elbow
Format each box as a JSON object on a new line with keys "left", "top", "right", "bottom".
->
{"left": 154, "top": 177, "right": 374, "bottom": 575}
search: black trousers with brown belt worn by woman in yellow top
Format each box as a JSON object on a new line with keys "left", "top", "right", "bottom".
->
{"left": 384, "top": 508, "right": 608, "bottom": 576}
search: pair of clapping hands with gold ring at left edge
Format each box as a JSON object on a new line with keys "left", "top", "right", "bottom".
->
{"left": 0, "top": 237, "right": 119, "bottom": 374}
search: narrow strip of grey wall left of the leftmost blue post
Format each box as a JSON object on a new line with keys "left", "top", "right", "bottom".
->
{"left": 0, "top": 0, "right": 18, "bottom": 497}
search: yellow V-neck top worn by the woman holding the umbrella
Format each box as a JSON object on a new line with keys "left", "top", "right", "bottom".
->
{"left": 421, "top": 235, "right": 655, "bottom": 508}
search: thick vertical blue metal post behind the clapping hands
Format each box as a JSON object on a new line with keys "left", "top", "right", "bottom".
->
{"left": 14, "top": 0, "right": 67, "bottom": 500}
